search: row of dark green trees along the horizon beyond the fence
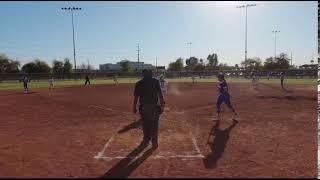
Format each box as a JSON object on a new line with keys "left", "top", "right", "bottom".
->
{"left": 0, "top": 53, "right": 314, "bottom": 74}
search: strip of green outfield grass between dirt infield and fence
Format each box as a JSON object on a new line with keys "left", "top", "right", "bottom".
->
{"left": 0, "top": 78, "right": 318, "bottom": 90}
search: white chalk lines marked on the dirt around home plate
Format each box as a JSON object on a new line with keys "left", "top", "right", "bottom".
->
{"left": 89, "top": 105, "right": 204, "bottom": 161}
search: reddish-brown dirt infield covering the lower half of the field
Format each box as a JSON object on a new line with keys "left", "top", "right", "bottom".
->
{"left": 0, "top": 83, "right": 317, "bottom": 178}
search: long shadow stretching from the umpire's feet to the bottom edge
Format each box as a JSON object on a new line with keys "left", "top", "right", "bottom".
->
{"left": 100, "top": 143, "right": 155, "bottom": 178}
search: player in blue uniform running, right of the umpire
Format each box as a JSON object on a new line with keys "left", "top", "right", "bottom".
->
{"left": 217, "top": 74, "right": 237, "bottom": 120}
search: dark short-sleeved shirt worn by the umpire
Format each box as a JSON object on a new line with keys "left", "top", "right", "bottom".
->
{"left": 134, "top": 78, "right": 161, "bottom": 105}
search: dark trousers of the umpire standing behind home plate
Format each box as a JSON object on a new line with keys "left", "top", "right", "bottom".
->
{"left": 140, "top": 104, "right": 160, "bottom": 145}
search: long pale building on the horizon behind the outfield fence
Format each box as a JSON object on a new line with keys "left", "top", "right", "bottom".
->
{"left": 99, "top": 61, "right": 155, "bottom": 71}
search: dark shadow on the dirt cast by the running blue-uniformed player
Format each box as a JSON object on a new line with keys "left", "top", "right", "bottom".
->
{"left": 203, "top": 120, "right": 238, "bottom": 169}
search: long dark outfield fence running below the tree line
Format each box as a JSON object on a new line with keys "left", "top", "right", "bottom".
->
{"left": 0, "top": 70, "right": 318, "bottom": 81}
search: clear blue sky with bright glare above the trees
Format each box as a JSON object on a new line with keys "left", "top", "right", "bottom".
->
{"left": 0, "top": 1, "right": 318, "bottom": 68}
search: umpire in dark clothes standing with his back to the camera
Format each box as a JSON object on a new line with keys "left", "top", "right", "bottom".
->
{"left": 133, "top": 69, "right": 165, "bottom": 149}
